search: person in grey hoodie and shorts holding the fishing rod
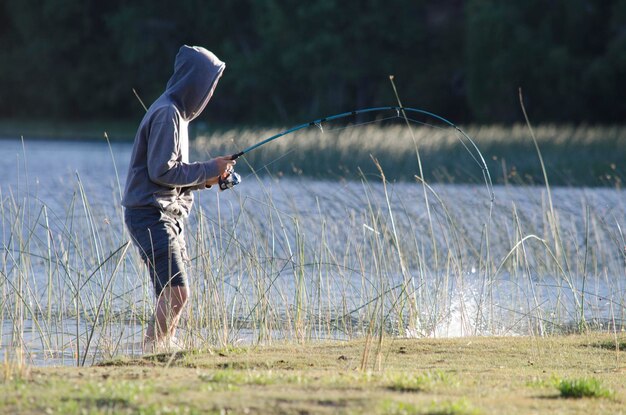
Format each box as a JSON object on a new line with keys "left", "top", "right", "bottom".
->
{"left": 122, "top": 45, "right": 235, "bottom": 352}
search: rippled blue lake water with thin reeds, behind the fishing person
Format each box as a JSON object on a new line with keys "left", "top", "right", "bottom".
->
{"left": 0, "top": 140, "right": 626, "bottom": 364}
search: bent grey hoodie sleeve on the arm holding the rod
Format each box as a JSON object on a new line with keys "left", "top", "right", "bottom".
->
{"left": 147, "top": 111, "right": 219, "bottom": 189}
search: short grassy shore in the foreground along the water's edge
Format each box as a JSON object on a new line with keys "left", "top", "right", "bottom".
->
{"left": 0, "top": 333, "right": 626, "bottom": 415}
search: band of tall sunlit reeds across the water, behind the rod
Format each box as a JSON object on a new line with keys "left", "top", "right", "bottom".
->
{"left": 194, "top": 120, "right": 626, "bottom": 187}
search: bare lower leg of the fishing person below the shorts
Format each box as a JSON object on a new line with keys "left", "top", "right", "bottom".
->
{"left": 144, "top": 286, "right": 189, "bottom": 345}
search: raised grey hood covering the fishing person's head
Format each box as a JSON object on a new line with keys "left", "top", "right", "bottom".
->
{"left": 165, "top": 45, "right": 226, "bottom": 121}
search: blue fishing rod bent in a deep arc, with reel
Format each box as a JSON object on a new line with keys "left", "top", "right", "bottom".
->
{"left": 220, "top": 106, "right": 494, "bottom": 200}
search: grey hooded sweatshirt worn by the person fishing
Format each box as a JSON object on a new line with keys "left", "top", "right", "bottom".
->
{"left": 122, "top": 46, "right": 225, "bottom": 216}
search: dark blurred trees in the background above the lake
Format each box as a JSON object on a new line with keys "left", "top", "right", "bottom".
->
{"left": 0, "top": 0, "right": 626, "bottom": 125}
